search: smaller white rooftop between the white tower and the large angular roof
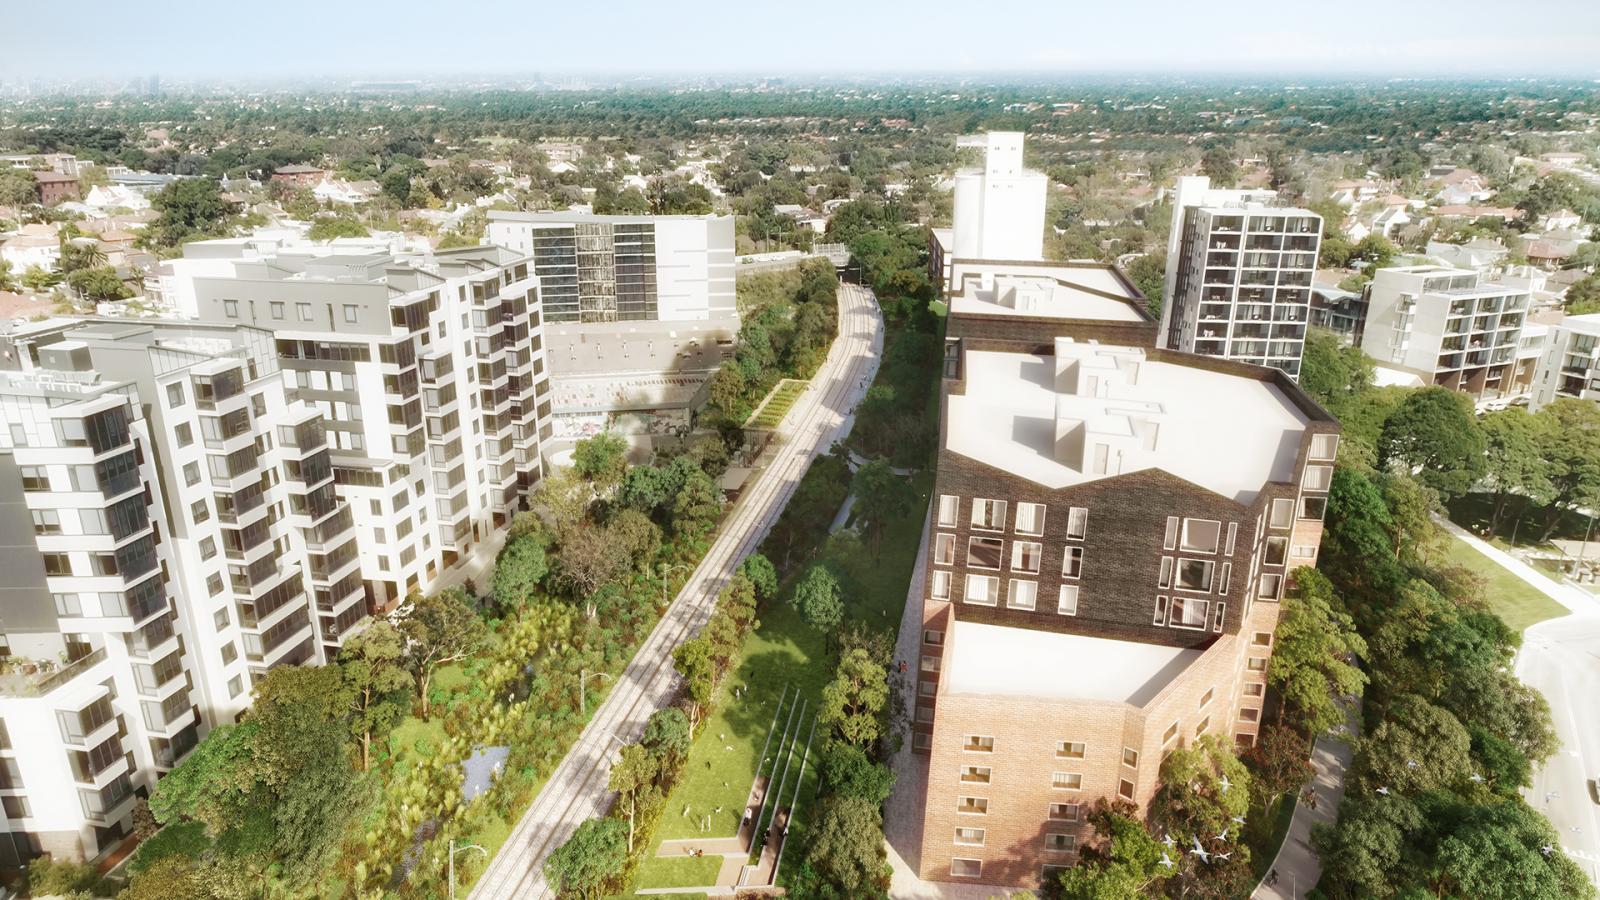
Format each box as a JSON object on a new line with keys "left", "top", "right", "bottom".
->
{"left": 950, "top": 267, "right": 1147, "bottom": 322}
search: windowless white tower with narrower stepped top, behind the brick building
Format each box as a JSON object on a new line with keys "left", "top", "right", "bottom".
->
{"left": 954, "top": 131, "right": 1048, "bottom": 261}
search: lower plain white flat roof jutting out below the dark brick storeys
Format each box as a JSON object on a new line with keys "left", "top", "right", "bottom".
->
{"left": 944, "top": 620, "right": 1205, "bottom": 706}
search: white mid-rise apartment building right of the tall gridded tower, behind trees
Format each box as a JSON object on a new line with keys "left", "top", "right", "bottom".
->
{"left": 1362, "top": 266, "right": 1536, "bottom": 404}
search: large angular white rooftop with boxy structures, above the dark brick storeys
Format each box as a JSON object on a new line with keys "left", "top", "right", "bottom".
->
{"left": 946, "top": 338, "right": 1307, "bottom": 503}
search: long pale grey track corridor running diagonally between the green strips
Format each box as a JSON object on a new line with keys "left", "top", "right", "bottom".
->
{"left": 472, "top": 285, "right": 883, "bottom": 900}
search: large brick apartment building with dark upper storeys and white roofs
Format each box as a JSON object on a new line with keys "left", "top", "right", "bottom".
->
{"left": 912, "top": 263, "right": 1339, "bottom": 887}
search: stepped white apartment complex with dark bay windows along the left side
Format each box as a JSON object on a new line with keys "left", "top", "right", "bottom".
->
{"left": 0, "top": 247, "right": 549, "bottom": 863}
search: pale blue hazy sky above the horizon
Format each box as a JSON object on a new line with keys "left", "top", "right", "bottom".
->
{"left": 9, "top": 0, "right": 1600, "bottom": 82}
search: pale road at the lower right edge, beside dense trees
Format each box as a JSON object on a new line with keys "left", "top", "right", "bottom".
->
{"left": 1517, "top": 610, "right": 1600, "bottom": 882}
